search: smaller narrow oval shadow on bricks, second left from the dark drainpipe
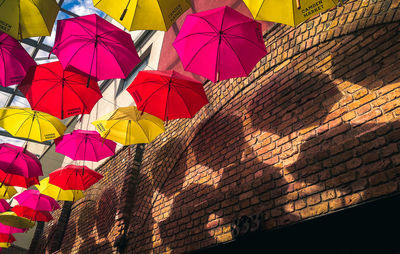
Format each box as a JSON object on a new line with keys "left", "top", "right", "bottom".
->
{"left": 76, "top": 200, "right": 97, "bottom": 239}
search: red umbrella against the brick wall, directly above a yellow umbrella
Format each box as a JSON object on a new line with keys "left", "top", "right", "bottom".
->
{"left": 127, "top": 71, "right": 208, "bottom": 121}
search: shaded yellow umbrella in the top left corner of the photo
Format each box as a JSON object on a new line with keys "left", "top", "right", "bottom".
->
{"left": 0, "top": 0, "right": 60, "bottom": 40}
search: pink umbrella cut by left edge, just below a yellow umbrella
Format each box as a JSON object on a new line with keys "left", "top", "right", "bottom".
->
{"left": 0, "top": 144, "right": 43, "bottom": 178}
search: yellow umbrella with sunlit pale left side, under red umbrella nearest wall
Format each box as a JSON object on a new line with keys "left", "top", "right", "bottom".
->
{"left": 92, "top": 107, "right": 165, "bottom": 145}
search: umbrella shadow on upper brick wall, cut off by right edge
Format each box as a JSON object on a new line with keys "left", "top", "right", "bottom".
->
{"left": 331, "top": 23, "right": 400, "bottom": 90}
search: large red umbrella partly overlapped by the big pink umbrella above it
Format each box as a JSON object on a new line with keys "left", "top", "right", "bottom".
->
{"left": 18, "top": 62, "right": 103, "bottom": 119}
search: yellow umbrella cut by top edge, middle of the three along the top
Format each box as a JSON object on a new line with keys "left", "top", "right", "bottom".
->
{"left": 93, "top": 0, "right": 190, "bottom": 31}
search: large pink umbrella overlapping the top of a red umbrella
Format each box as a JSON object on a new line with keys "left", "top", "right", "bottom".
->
{"left": 53, "top": 14, "right": 140, "bottom": 80}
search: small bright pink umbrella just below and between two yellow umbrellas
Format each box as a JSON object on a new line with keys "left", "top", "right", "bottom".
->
{"left": 55, "top": 130, "right": 117, "bottom": 161}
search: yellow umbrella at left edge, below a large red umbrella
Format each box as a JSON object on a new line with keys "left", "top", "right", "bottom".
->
{"left": 0, "top": 107, "right": 66, "bottom": 142}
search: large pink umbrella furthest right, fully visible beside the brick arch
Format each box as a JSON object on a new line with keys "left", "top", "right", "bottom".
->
{"left": 173, "top": 6, "right": 267, "bottom": 82}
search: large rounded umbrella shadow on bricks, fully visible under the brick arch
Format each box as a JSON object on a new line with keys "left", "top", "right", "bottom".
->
{"left": 247, "top": 72, "right": 342, "bottom": 137}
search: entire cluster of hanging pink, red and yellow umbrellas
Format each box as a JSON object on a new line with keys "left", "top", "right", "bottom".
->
{"left": 0, "top": 0, "right": 339, "bottom": 250}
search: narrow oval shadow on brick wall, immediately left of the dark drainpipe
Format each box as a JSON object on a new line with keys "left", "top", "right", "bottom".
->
{"left": 96, "top": 187, "right": 118, "bottom": 238}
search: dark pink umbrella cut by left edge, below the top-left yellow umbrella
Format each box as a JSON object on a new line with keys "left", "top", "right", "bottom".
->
{"left": 0, "top": 32, "right": 36, "bottom": 87}
